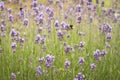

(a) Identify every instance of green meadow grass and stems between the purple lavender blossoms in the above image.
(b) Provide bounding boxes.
[0,0,120,80]
